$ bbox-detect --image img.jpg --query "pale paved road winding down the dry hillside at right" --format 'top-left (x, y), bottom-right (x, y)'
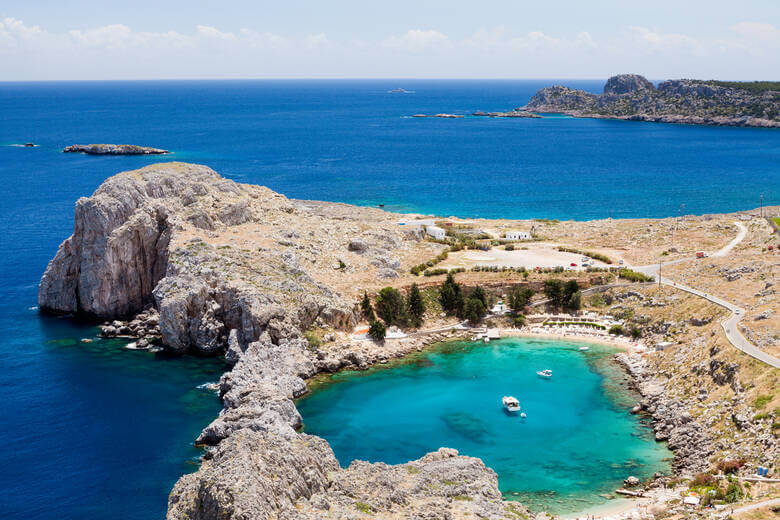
top-left (632, 222), bottom-right (780, 368)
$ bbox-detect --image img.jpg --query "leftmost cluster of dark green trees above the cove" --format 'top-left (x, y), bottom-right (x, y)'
top-left (360, 283), bottom-right (425, 341)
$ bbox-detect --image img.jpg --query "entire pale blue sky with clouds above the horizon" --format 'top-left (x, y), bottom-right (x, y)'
top-left (0, 0), bottom-right (780, 81)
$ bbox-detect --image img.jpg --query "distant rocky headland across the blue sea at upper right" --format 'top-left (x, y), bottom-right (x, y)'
top-left (524, 74), bottom-right (780, 128)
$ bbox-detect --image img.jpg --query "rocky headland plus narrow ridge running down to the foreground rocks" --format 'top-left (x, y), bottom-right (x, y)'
top-left (39, 163), bottom-right (532, 520)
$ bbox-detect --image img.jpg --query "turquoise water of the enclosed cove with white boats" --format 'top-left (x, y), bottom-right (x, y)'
top-left (298, 338), bottom-right (671, 514)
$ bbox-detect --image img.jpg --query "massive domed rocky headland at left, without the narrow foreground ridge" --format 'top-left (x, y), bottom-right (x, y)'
top-left (38, 163), bottom-right (419, 352)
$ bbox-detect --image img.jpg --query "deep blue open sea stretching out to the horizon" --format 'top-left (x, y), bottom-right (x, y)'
top-left (0, 80), bottom-right (780, 520)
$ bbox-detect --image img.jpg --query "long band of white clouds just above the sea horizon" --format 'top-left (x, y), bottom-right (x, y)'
top-left (0, 18), bottom-right (780, 80)
